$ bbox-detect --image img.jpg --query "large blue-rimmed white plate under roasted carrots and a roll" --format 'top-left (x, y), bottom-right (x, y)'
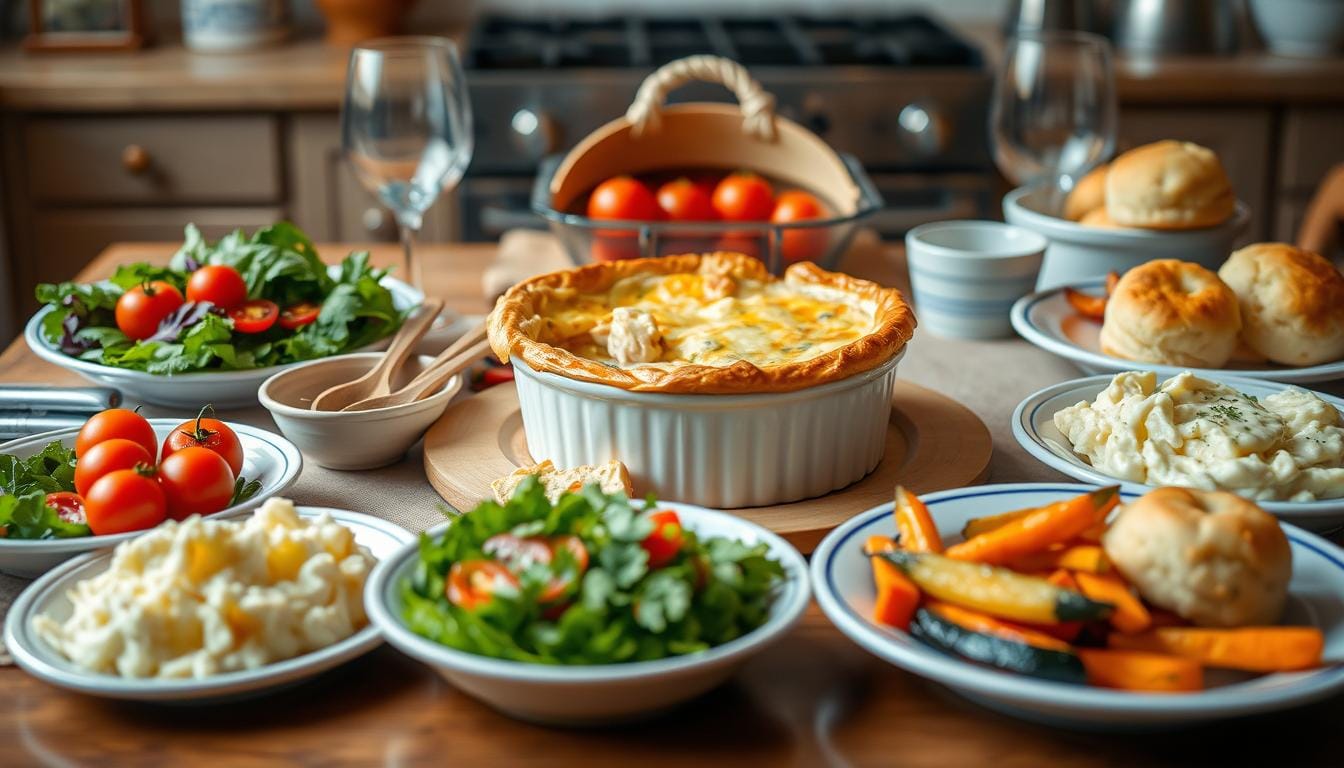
top-left (812, 483), bottom-right (1344, 729)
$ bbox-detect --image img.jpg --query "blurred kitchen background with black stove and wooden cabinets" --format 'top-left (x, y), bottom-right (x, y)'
top-left (0, 0), bottom-right (1344, 339)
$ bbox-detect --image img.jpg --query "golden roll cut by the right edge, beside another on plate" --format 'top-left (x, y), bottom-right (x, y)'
top-left (1218, 242), bottom-right (1344, 366)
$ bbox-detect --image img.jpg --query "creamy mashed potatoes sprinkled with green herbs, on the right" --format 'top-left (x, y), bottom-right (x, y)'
top-left (1054, 371), bottom-right (1344, 502)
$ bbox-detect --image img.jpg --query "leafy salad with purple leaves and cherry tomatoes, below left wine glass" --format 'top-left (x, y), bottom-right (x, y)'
top-left (36, 222), bottom-right (403, 374)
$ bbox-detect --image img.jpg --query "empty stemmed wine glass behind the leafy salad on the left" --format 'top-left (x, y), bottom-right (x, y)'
top-left (340, 36), bottom-right (472, 297)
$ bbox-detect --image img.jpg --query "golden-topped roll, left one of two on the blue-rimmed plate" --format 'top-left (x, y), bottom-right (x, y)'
top-left (1101, 258), bottom-right (1242, 369)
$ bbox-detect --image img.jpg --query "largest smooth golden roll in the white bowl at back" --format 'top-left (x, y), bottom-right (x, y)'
top-left (1106, 140), bottom-right (1236, 230)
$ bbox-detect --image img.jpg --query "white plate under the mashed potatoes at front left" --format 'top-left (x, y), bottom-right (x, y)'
top-left (4, 507), bottom-right (415, 703)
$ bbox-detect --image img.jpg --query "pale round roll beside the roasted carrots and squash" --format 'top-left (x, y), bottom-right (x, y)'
top-left (1102, 488), bottom-right (1293, 627)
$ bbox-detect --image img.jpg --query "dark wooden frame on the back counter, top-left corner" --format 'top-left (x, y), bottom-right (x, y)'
top-left (23, 0), bottom-right (148, 52)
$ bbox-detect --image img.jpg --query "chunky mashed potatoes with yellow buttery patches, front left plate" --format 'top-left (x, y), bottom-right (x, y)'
top-left (34, 499), bottom-right (374, 678)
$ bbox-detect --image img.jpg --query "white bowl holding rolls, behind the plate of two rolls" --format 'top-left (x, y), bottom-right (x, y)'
top-left (1004, 187), bottom-right (1251, 289)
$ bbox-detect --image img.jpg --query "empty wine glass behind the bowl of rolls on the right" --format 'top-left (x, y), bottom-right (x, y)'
top-left (989, 31), bottom-right (1116, 208)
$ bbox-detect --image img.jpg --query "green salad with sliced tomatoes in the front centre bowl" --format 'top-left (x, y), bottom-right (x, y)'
top-left (401, 479), bottom-right (784, 664)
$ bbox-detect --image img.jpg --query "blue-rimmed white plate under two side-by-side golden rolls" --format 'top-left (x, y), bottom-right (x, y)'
top-left (1009, 280), bottom-right (1344, 383)
